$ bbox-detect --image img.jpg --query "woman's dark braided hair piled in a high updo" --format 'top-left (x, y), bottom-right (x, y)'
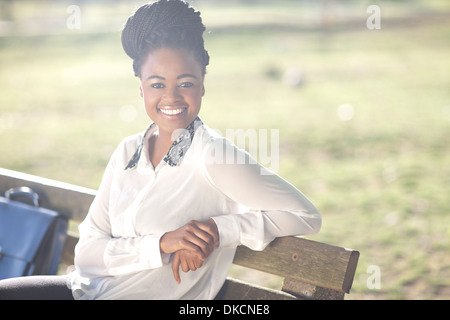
top-left (122, 0), bottom-right (209, 77)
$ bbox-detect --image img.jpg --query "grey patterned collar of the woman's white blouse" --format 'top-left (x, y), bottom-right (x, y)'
top-left (124, 116), bottom-right (203, 170)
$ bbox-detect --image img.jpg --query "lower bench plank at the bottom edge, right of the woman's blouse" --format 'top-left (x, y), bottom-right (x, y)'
top-left (216, 278), bottom-right (298, 300)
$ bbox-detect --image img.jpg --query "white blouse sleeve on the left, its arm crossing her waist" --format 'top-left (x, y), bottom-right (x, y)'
top-left (75, 142), bottom-right (167, 276)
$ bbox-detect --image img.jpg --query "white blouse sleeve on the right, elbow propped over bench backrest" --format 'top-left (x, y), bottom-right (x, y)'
top-left (205, 139), bottom-right (321, 250)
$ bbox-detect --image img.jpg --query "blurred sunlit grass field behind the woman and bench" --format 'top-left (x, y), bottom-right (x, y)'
top-left (0, 0), bottom-right (450, 299)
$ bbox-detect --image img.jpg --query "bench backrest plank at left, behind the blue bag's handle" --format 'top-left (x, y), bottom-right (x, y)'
top-left (0, 168), bottom-right (96, 222)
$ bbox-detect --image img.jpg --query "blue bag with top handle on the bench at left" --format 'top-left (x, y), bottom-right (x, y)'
top-left (0, 187), bottom-right (67, 279)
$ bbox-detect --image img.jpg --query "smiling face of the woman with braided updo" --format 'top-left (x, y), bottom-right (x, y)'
top-left (140, 47), bottom-right (204, 135)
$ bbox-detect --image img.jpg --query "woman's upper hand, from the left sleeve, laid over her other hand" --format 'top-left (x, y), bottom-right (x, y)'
top-left (159, 219), bottom-right (219, 261)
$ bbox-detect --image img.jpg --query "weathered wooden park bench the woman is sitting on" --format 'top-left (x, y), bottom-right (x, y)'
top-left (0, 168), bottom-right (359, 300)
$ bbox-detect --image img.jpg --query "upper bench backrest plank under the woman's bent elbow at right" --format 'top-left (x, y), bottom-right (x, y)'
top-left (234, 237), bottom-right (359, 293)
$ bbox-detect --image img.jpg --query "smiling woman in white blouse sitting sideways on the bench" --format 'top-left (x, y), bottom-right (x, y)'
top-left (0, 0), bottom-right (321, 299)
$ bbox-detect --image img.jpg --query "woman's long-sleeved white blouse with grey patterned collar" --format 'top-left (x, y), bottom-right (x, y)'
top-left (69, 117), bottom-right (321, 299)
